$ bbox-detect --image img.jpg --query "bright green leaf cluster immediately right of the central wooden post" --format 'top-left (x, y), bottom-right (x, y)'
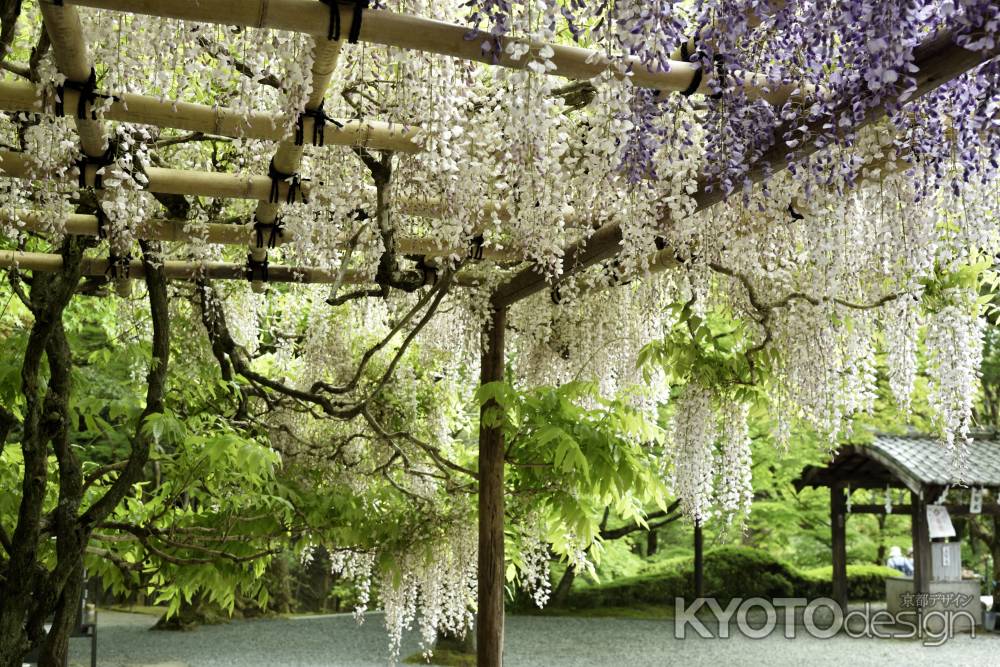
top-left (477, 382), bottom-right (666, 578)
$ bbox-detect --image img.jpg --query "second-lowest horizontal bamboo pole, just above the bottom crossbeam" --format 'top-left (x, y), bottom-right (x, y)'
top-left (0, 210), bottom-right (521, 261)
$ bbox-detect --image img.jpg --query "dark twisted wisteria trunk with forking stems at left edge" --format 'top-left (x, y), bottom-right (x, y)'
top-left (0, 236), bottom-right (170, 667)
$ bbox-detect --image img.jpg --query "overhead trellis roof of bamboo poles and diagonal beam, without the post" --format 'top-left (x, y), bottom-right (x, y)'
top-left (0, 0), bottom-right (992, 298)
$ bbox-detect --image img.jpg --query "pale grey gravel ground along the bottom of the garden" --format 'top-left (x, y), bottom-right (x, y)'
top-left (71, 612), bottom-right (1000, 667)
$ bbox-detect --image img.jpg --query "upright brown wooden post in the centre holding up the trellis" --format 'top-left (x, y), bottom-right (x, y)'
top-left (476, 307), bottom-right (507, 667)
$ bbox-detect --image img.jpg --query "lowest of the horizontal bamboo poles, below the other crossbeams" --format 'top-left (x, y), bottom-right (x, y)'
top-left (0, 250), bottom-right (482, 287)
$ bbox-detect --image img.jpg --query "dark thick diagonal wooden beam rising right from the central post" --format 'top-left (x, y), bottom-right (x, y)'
top-left (493, 33), bottom-right (1000, 306)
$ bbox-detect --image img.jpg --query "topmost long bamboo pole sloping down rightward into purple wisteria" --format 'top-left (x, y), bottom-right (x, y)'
top-left (66, 0), bottom-right (795, 103)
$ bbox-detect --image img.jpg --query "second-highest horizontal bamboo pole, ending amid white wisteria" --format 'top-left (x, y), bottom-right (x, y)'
top-left (0, 81), bottom-right (420, 153)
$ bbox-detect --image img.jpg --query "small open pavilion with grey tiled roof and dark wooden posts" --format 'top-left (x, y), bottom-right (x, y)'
top-left (795, 435), bottom-right (1000, 609)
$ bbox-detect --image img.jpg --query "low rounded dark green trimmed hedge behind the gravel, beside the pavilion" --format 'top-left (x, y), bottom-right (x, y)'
top-left (563, 546), bottom-right (898, 609)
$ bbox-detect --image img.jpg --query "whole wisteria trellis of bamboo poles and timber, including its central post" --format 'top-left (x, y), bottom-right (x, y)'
top-left (0, 0), bottom-right (995, 667)
